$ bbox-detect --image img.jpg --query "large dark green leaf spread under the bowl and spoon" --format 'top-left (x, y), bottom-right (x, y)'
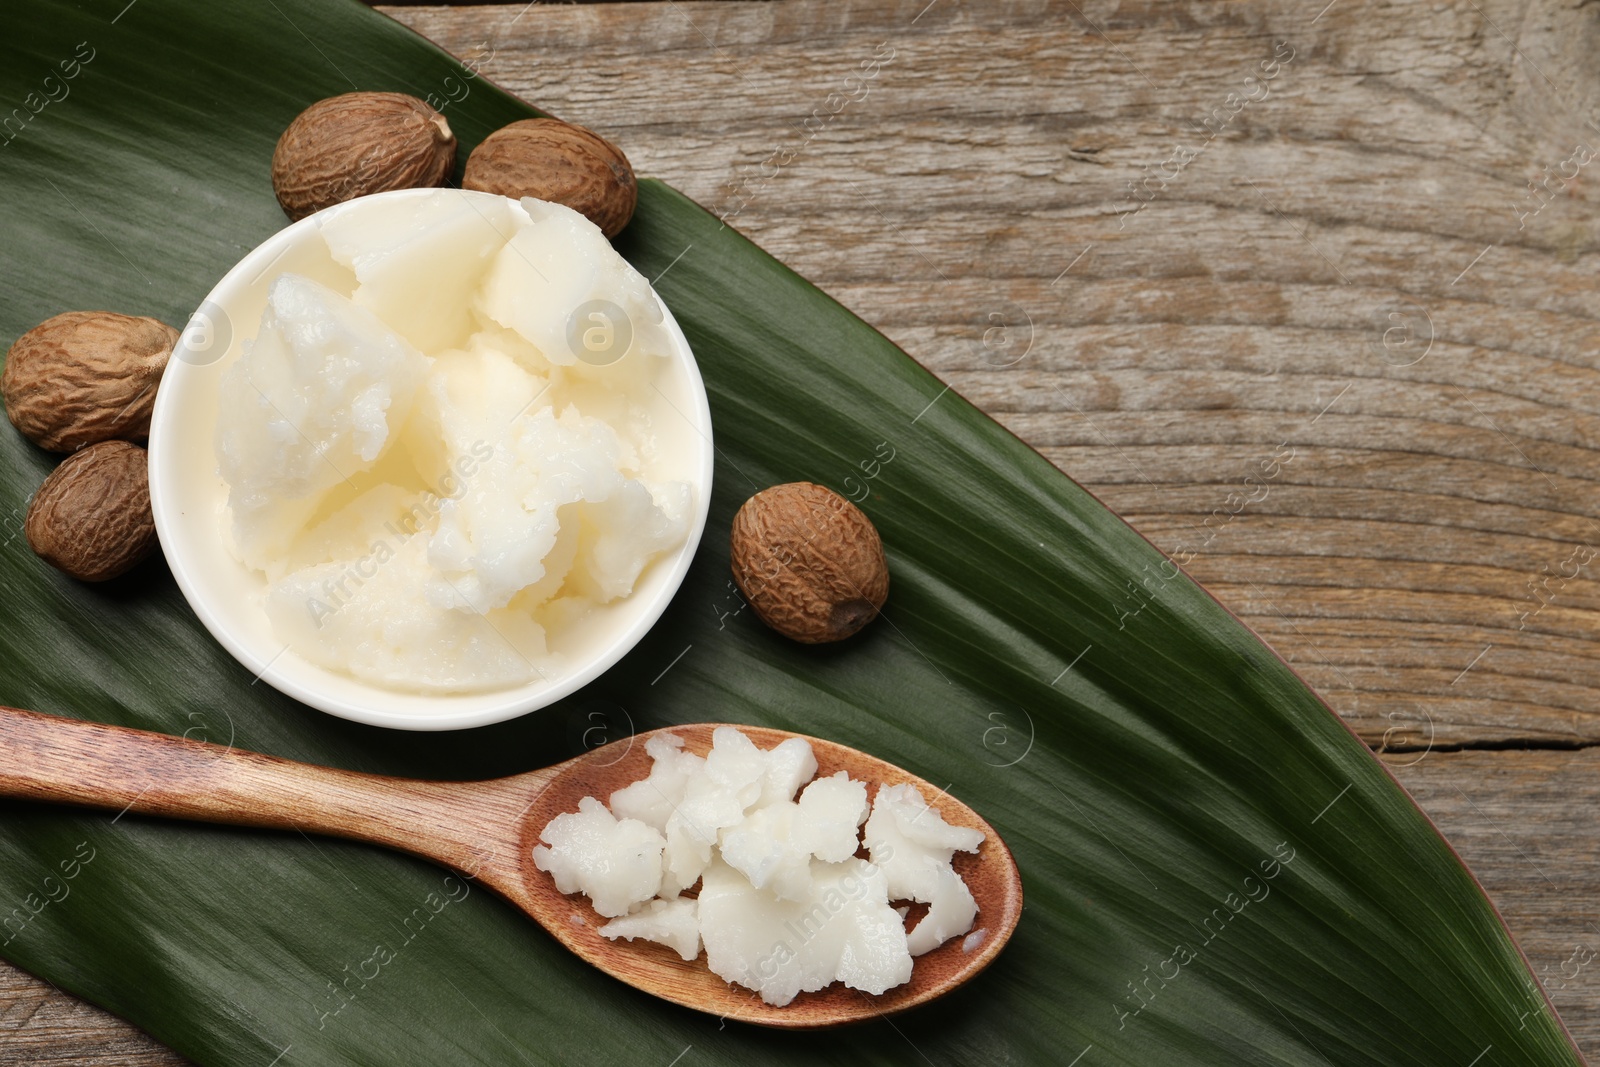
top-left (0, 0), bottom-right (1581, 1067)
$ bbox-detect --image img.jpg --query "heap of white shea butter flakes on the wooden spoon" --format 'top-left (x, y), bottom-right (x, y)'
top-left (536, 726), bottom-right (982, 1005)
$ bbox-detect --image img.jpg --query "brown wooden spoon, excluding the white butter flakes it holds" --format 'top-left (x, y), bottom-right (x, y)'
top-left (0, 709), bottom-right (1022, 1029)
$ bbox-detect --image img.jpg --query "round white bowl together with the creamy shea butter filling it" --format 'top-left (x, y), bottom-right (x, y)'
top-left (150, 189), bottom-right (712, 729)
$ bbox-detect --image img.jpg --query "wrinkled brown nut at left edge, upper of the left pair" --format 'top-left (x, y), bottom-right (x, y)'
top-left (0, 312), bottom-right (178, 453)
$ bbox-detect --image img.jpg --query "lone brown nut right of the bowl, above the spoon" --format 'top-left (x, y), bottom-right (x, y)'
top-left (733, 482), bottom-right (890, 645)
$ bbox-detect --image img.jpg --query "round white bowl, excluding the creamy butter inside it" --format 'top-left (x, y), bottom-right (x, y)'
top-left (150, 189), bottom-right (714, 729)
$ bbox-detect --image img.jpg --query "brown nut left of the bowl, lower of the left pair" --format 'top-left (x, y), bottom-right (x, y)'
top-left (22, 442), bottom-right (157, 582)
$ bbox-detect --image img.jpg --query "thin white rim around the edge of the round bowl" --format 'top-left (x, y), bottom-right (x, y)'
top-left (149, 189), bottom-right (715, 731)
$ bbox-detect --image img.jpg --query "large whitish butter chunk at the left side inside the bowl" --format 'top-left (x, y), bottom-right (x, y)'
top-left (216, 274), bottom-right (429, 576)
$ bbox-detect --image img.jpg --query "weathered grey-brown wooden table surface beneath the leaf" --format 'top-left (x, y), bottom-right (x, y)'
top-left (0, 0), bottom-right (1600, 1067)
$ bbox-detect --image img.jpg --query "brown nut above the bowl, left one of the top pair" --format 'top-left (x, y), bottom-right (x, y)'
top-left (272, 93), bottom-right (456, 219)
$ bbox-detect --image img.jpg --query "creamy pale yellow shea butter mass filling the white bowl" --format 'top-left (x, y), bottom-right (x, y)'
top-left (216, 190), bottom-right (699, 694)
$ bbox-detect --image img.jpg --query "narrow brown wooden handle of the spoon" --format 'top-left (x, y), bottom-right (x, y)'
top-left (0, 707), bottom-right (544, 873)
